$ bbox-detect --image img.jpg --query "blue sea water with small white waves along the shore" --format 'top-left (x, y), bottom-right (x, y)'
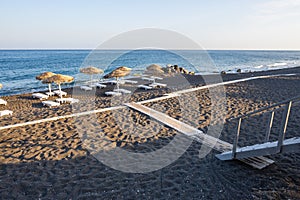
top-left (0, 50), bottom-right (300, 96)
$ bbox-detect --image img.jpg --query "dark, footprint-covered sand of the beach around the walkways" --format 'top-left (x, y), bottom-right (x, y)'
top-left (0, 68), bottom-right (300, 199)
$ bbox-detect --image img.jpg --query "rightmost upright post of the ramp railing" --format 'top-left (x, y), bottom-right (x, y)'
top-left (276, 101), bottom-right (292, 153)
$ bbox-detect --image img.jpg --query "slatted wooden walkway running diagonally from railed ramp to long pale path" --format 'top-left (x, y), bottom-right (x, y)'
top-left (125, 103), bottom-right (274, 169)
